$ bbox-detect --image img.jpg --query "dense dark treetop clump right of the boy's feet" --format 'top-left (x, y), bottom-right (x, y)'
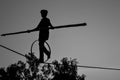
top-left (52, 58), bottom-right (85, 80)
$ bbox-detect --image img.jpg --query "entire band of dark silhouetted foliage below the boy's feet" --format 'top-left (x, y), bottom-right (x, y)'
top-left (0, 53), bottom-right (85, 80)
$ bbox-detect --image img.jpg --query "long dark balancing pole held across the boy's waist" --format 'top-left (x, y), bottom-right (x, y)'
top-left (1, 23), bottom-right (87, 36)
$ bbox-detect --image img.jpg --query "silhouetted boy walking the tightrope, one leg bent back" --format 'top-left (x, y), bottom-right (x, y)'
top-left (34, 9), bottom-right (53, 63)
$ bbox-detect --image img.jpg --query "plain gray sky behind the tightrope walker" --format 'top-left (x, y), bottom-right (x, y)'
top-left (0, 0), bottom-right (120, 80)
